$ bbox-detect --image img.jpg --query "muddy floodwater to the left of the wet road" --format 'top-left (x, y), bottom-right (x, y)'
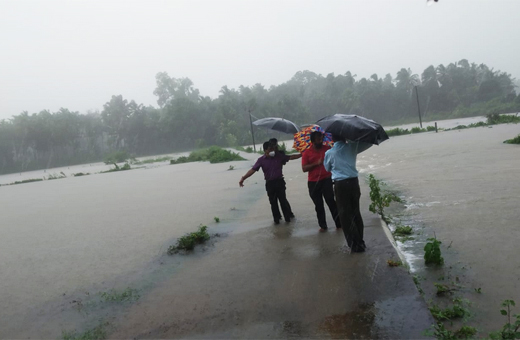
top-left (0, 154), bottom-right (264, 338)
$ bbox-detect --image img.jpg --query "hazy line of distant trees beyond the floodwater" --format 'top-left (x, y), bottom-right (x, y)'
top-left (0, 59), bottom-right (520, 174)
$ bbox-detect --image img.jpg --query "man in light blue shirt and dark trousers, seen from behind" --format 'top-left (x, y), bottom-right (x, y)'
top-left (323, 134), bottom-right (372, 253)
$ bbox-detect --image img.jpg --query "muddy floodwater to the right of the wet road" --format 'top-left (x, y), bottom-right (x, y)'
top-left (359, 120), bottom-right (520, 334)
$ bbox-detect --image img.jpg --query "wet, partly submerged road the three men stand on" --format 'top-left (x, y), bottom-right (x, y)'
top-left (110, 162), bottom-right (433, 339)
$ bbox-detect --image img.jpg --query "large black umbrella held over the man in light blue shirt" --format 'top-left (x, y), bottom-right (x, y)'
top-left (316, 113), bottom-right (388, 144)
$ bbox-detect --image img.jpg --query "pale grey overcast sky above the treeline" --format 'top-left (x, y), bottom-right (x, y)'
top-left (0, 0), bottom-right (520, 119)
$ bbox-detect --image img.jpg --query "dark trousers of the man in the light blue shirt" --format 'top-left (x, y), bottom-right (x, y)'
top-left (334, 177), bottom-right (365, 251)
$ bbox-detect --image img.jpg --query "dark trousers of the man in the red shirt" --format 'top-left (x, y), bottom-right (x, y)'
top-left (307, 177), bottom-right (341, 229)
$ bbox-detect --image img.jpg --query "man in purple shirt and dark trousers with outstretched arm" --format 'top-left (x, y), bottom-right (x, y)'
top-left (238, 142), bottom-right (302, 224)
